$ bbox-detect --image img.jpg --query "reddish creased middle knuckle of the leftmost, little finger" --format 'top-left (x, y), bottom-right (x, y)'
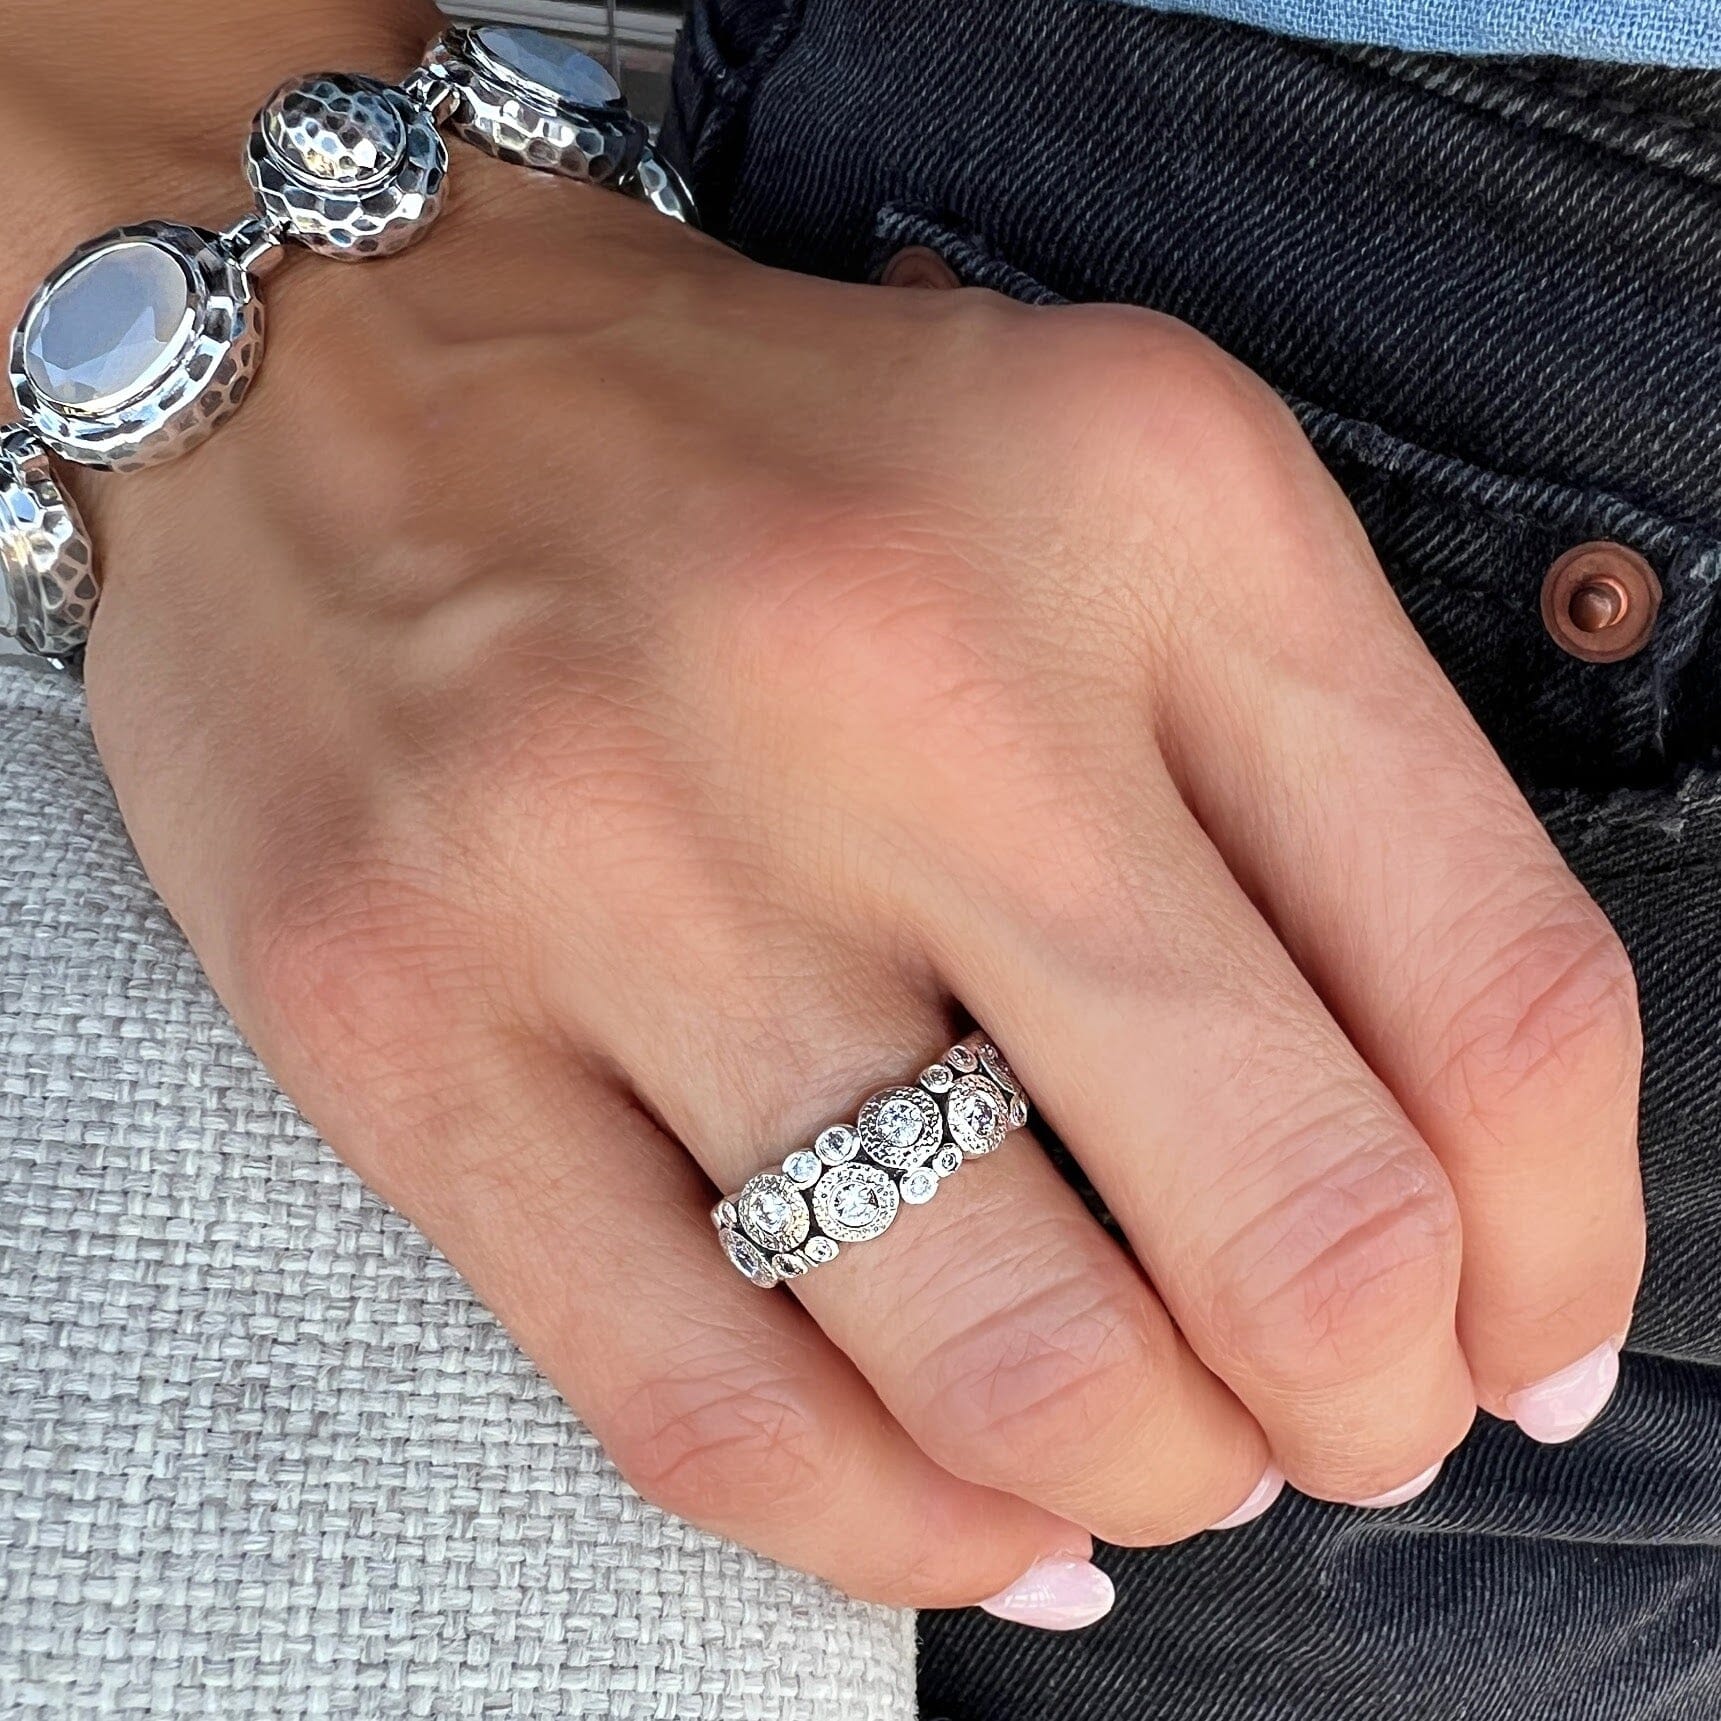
top-left (604, 1360), bottom-right (831, 1525)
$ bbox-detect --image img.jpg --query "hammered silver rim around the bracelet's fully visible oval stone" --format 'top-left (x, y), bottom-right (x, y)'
top-left (10, 220), bottom-right (263, 472)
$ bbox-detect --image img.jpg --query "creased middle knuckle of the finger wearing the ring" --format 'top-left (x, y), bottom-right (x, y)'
top-left (917, 1268), bottom-right (1163, 1485)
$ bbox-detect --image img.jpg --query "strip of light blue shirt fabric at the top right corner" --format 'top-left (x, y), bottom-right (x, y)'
top-left (1108, 0), bottom-right (1721, 67)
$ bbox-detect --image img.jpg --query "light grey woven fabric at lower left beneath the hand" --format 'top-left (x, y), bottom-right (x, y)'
top-left (0, 661), bottom-right (914, 1721)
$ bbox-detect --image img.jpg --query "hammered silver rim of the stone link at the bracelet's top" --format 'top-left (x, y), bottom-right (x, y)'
top-left (423, 24), bottom-right (647, 186)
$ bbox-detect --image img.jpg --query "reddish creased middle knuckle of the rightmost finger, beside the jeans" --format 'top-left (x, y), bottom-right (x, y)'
top-left (1427, 902), bottom-right (1644, 1124)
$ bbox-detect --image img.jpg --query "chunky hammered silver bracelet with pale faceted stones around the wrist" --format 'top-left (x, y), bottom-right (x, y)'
top-left (0, 24), bottom-right (697, 666)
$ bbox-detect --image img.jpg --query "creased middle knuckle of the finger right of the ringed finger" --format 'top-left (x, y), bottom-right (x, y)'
top-left (1200, 1115), bottom-right (1459, 1392)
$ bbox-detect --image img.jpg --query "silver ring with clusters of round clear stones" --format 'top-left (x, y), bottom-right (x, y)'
top-left (711, 1034), bottom-right (1029, 1291)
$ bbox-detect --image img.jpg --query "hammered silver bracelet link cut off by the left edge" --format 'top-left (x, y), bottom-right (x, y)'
top-left (0, 427), bottom-right (102, 663)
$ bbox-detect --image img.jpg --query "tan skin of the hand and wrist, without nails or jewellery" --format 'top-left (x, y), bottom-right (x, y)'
top-left (0, 0), bottom-right (1644, 1606)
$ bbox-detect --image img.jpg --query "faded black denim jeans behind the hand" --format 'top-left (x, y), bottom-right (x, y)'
top-left (669, 0), bottom-right (1721, 1721)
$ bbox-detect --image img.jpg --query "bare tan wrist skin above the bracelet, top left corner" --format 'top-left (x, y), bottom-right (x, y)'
top-left (0, 0), bottom-right (442, 324)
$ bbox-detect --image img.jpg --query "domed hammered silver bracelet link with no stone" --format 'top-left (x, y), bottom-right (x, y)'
top-left (244, 72), bottom-right (447, 262)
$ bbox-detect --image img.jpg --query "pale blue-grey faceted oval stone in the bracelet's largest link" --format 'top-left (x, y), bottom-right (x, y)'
top-left (24, 239), bottom-right (196, 415)
